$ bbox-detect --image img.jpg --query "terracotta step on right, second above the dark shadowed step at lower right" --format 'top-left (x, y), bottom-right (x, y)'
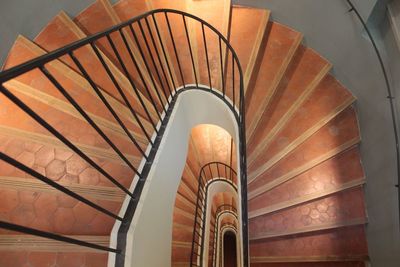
top-left (248, 147), bottom-right (365, 218)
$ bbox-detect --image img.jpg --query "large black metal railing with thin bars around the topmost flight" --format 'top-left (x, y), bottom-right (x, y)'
top-left (0, 9), bottom-right (248, 266)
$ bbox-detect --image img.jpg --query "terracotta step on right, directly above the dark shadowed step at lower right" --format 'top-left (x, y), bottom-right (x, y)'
top-left (249, 187), bottom-right (366, 240)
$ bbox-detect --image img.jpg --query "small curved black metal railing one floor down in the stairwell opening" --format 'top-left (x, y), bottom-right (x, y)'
top-left (189, 162), bottom-right (237, 266)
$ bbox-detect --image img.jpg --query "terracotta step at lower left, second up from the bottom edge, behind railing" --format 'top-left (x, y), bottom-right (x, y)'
top-left (0, 183), bottom-right (121, 236)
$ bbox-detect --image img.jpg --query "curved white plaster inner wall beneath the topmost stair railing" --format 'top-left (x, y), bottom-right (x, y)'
top-left (109, 90), bottom-right (241, 267)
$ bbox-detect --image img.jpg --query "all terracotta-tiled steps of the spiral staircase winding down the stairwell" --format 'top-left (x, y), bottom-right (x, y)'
top-left (0, 0), bottom-right (368, 267)
